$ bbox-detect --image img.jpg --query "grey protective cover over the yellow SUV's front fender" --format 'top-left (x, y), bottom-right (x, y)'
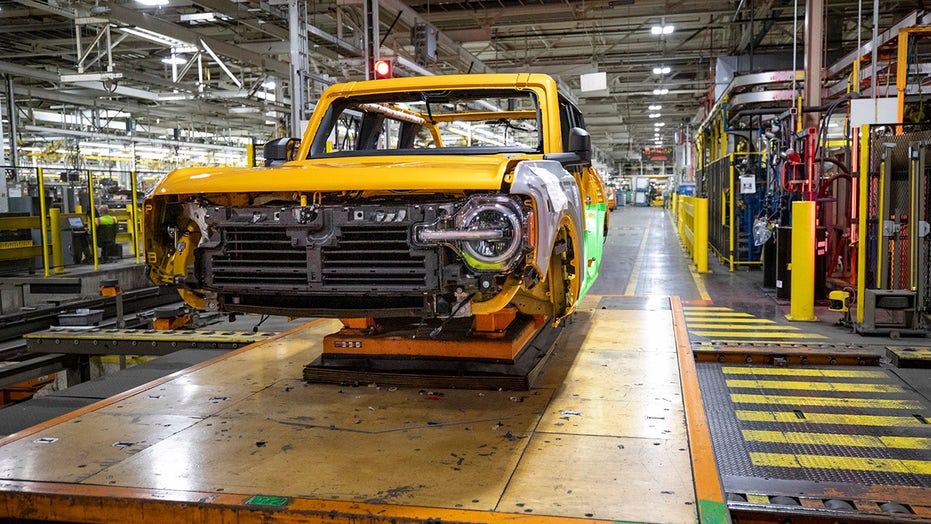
top-left (511, 160), bottom-right (585, 279)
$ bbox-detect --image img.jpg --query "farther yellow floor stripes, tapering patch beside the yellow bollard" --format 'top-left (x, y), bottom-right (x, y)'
top-left (683, 306), bottom-right (827, 344)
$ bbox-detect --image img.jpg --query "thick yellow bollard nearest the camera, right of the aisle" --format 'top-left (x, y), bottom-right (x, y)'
top-left (786, 201), bottom-right (818, 322)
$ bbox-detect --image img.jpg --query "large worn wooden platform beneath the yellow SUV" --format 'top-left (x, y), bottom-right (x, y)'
top-left (0, 297), bottom-right (699, 523)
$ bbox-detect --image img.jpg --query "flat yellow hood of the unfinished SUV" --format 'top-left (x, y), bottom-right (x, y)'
top-left (150, 155), bottom-right (524, 197)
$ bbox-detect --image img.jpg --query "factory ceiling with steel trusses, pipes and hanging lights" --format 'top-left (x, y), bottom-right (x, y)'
top-left (0, 0), bottom-right (923, 171)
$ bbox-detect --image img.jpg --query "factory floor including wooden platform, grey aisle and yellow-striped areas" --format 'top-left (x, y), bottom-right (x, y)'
top-left (0, 207), bottom-right (931, 523)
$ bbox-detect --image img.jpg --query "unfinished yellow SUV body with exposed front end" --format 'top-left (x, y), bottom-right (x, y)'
top-left (144, 74), bottom-right (607, 322)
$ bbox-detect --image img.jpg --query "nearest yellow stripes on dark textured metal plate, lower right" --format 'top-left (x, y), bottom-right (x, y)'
top-left (719, 365), bottom-right (931, 482)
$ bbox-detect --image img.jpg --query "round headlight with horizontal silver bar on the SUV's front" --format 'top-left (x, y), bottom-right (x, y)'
top-left (415, 195), bottom-right (529, 271)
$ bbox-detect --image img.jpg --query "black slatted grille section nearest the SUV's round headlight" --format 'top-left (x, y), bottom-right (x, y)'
top-left (321, 226), bottom-right (427, 291)
